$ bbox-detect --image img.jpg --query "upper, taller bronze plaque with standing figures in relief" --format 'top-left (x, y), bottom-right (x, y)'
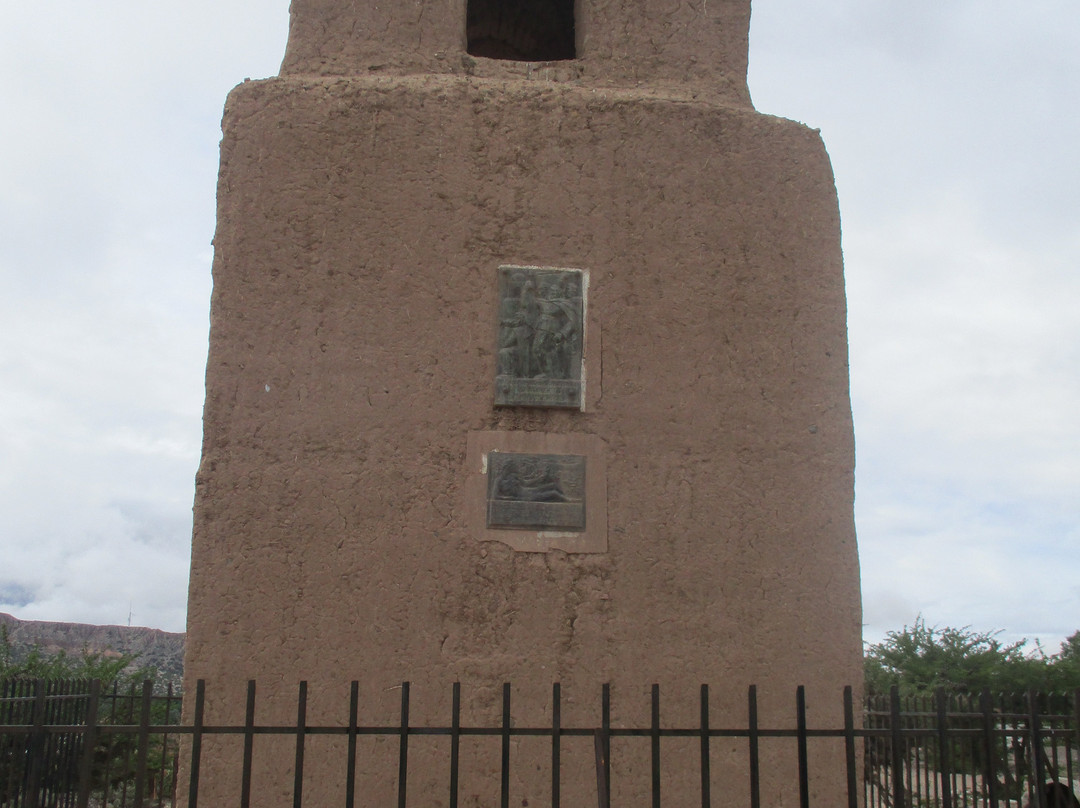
top-left (495, 267), bottom-right (584, 409)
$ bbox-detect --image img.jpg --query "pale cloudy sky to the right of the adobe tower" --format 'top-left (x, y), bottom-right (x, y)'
top-left (751, 0), bottom-right (1080, 649)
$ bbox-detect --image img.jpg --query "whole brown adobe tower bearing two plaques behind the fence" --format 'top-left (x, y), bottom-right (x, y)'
top-left (186, 0), bottom-right (861, 806)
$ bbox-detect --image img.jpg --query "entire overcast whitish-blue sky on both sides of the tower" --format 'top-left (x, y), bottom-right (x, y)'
top-left (0, 0), bottom-right (1080, 651)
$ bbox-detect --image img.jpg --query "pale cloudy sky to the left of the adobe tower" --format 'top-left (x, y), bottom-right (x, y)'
top-left (0, 0), bottom-right (287, 631)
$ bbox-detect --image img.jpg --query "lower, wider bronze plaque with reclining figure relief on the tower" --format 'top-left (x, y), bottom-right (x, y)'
top-left (487, 452), bottom-right (585, 531)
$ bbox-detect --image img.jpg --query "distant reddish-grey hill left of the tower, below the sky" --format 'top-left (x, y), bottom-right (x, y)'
top-left (0, 612), bottom-right (184, 684)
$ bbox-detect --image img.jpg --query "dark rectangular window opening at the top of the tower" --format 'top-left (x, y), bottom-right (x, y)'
top-left (465, 0), bottom-right (576, 62)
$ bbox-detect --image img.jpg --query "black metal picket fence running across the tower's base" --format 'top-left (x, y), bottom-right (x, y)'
top-left (0, 681), bottom-right (1080, 808)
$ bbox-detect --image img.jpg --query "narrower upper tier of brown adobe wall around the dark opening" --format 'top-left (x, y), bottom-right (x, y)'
top-left (281, 0), bottom-right (750, 106)
